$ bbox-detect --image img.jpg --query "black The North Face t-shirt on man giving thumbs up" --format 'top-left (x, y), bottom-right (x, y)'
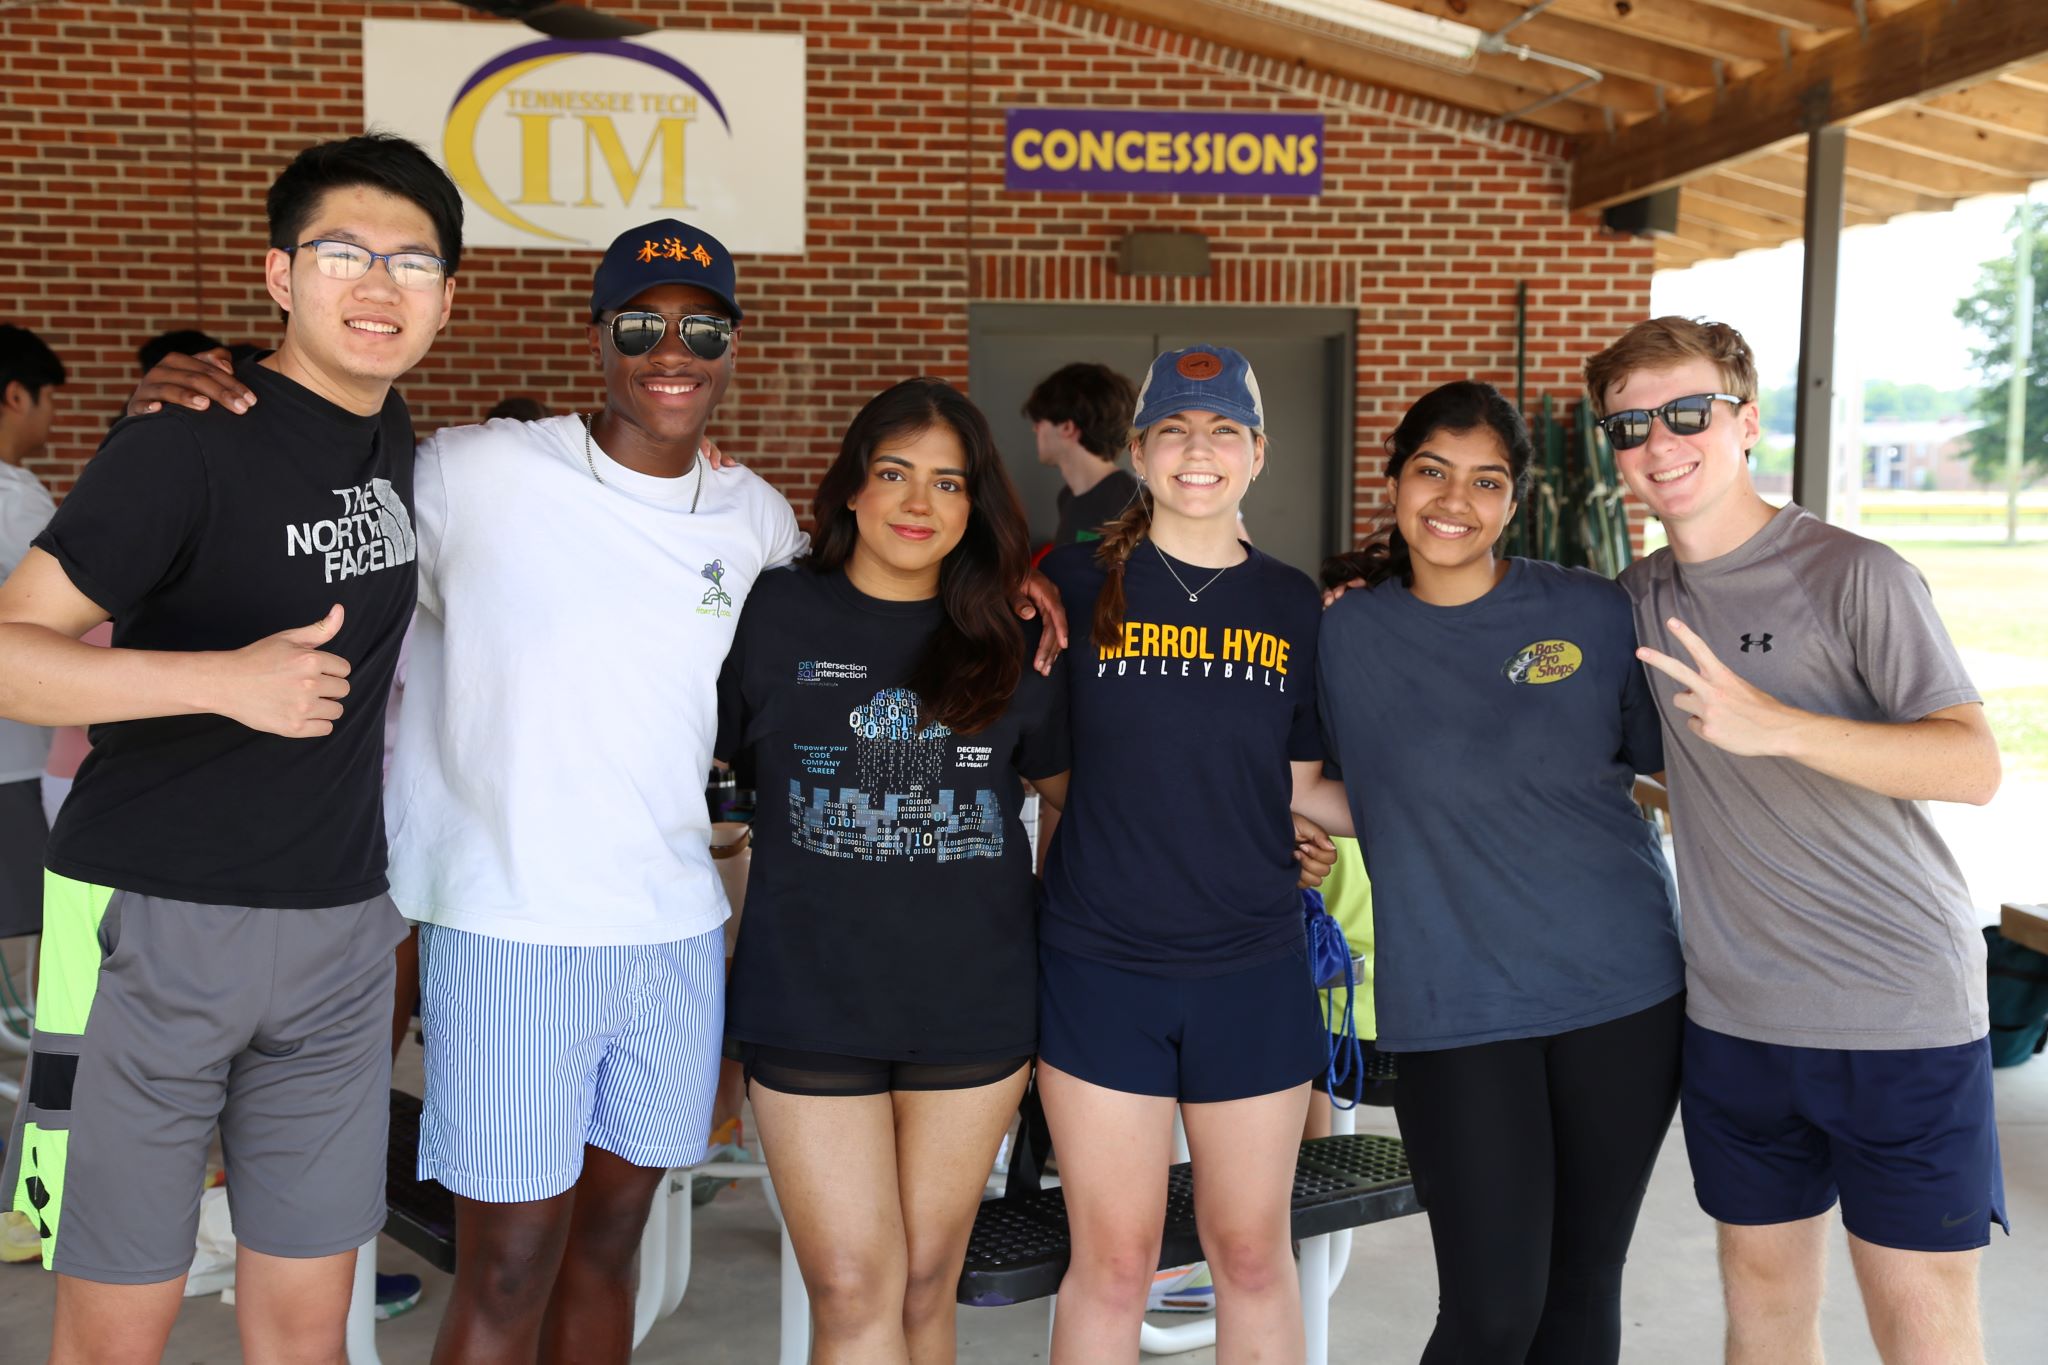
top-left (35, 360), bottom-right (418, 909)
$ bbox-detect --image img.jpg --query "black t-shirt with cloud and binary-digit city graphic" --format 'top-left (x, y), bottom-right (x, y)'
top-left (717, 567), bottom-right (1067, 1062)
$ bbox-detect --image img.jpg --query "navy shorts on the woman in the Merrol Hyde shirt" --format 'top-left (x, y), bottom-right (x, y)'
top-left (1038, 943), bottom-right (1329, 1105)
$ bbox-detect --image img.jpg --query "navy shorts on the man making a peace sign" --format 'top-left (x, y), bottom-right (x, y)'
top-left (1679, 1019), bottom-right (2011, 1250)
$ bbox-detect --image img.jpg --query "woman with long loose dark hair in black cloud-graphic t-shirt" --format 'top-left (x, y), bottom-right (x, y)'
top-left (717, 379), bottom-right (1067, 1365)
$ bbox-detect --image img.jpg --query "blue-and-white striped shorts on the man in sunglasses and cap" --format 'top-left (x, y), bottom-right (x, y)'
top-left (420, 925), bottom-right (725, 1203)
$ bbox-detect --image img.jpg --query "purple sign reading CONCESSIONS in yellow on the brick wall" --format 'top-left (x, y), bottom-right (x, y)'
top-left (1004, 106), bottom-right (1323, 196)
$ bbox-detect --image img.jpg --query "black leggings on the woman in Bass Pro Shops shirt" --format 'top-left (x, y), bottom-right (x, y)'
top-left (1395, 993), bottom-right (1686, 1365)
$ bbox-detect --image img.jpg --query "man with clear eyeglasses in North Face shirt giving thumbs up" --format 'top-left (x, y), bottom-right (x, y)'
top-left (0, 135), bottom-right (463, 1365)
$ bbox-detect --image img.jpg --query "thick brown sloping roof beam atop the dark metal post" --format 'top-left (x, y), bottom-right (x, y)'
top-left (1571, 0), bottom-right (2048, 209)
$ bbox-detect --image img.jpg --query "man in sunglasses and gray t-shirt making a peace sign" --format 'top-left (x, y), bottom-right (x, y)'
top-left (1585, 317), bottom-right (2005, 1365)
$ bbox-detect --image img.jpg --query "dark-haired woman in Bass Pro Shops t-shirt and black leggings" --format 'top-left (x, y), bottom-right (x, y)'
top-left (1317, 381), bottom-right (1686, 1365)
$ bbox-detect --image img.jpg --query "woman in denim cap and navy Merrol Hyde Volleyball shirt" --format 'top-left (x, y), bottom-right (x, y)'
top-left (1038, 346), bottom-right (1348, 1361)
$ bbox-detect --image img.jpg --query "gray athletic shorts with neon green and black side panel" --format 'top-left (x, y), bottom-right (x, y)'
top-left (0, 874), bottom-right (406, 1285)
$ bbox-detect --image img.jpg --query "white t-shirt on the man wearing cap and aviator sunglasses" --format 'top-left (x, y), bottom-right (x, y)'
top-left (385, 417), bottom-right (809, 945)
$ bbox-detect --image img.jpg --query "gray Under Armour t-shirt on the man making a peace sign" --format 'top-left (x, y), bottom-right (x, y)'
top-left (1622, 505), bottom-right (1989, 1048)
